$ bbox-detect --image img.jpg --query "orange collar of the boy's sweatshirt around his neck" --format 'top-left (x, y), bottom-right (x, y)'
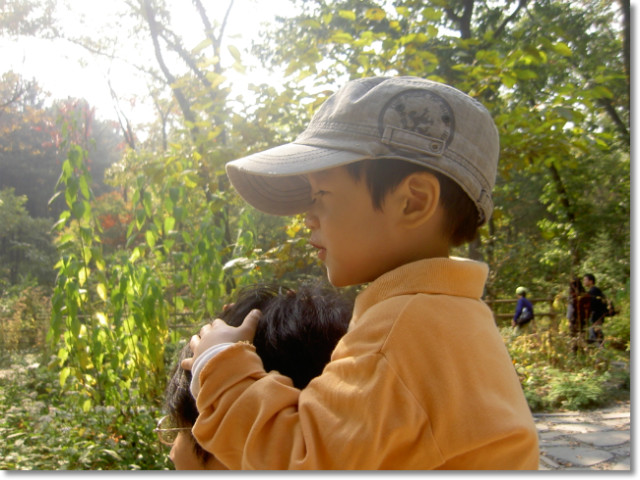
top-left (353, 257), bottom-right (489, 319)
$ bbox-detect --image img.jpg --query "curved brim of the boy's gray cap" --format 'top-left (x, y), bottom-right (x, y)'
top-left (226, 143), bottom-right (368, 215)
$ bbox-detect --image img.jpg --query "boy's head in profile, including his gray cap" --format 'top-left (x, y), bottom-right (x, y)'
top-left (227, 77), bottom-right (499, 286)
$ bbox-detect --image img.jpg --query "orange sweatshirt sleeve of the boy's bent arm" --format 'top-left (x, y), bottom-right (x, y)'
top-left (193, 344), bottom-right (443, 470)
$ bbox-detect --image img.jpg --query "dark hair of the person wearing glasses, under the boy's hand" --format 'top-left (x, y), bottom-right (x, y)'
top-left (165, 284), bottom-right (353, 463)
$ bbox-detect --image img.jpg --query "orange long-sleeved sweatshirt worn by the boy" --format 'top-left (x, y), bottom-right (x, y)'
top-left (193, 258), bottom-right (539, 470)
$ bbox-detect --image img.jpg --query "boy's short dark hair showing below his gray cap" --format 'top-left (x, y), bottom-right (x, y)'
top-left (346, 158), bottom-right (479, 247)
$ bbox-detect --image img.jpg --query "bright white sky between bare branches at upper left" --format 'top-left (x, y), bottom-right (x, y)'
top-left (0, 0), bottom-right (291, 124)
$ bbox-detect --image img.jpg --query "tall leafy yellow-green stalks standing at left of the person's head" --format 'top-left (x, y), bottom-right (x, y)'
top-left (47, 146), bottom-right (168, 411)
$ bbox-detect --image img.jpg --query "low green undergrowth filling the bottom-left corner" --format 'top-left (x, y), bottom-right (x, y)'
top-left (0, 355), bottom-right (171, 470)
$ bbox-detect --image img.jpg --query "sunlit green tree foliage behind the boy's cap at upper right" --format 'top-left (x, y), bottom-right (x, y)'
top-left (254, 0), bottom-right (630, 298)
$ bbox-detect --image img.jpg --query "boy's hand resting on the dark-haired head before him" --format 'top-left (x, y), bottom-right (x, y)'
top-left (180, 310), bottom-right (262, 370)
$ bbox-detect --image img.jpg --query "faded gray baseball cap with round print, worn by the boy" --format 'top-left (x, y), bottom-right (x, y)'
top-left (226, 77), bottom-right (500, 224)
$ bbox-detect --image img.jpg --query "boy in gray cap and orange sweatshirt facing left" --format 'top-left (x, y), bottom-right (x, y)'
top-left (183, 77), bottom-right (538, 469)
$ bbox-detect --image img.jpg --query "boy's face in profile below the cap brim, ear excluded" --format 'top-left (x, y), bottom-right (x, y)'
top-left (305, 167), bottom-right (405, 287)
